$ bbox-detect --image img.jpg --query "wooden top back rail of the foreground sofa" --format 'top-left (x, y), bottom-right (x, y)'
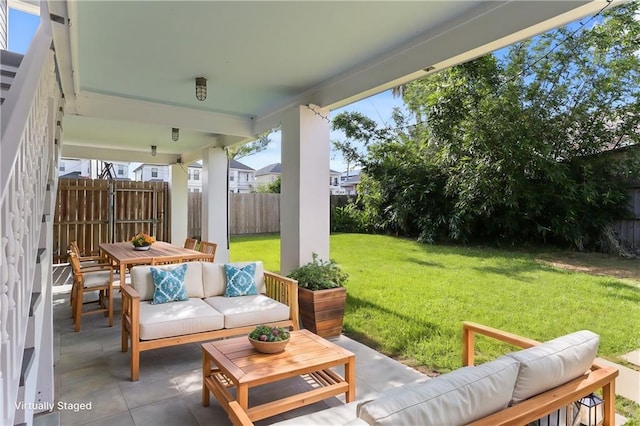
top-left (469, 367), bottom-right (618, 426)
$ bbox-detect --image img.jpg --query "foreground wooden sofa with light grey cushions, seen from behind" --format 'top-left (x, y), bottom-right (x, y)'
top-left (229, 322), bottom-right (618, 426)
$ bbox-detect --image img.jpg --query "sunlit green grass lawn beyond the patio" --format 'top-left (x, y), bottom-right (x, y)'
top-left (231, 234), bottom-right (640, 373)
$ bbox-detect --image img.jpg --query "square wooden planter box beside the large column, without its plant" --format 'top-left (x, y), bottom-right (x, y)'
top-left (298, 287), bottom-right (347, 337)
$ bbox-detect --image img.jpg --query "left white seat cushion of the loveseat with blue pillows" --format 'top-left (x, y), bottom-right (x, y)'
top-left (140, 298), bottom-right (224, 340)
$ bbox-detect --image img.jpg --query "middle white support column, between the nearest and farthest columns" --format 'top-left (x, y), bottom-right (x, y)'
top-left (200, 148), bottom-right (229, 263)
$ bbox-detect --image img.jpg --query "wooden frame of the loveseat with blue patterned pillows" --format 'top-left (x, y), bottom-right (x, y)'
top-left (120, 271), bottom-right (299, 381)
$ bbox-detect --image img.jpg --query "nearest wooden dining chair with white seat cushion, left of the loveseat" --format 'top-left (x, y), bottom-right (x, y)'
top-left (69, 250), bottom-right (113, 331)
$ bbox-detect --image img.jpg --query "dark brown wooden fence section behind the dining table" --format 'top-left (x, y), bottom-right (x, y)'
top-left (53, 178), bottom-right (171, 262)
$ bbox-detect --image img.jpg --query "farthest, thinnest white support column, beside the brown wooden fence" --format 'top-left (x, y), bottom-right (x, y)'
top-left (169, 164), bottom-right (189, 246)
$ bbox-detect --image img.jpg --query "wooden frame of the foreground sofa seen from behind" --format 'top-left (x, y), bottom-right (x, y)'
top-left (228, 322), bottom-right (618, 426)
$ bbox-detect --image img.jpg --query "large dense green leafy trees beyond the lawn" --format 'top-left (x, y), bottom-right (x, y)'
top-left (363, 2), bottom-right (640, 249)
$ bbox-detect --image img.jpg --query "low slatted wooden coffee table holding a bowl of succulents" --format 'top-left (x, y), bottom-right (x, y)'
top-left (202, 330), bottom-right (356, 422)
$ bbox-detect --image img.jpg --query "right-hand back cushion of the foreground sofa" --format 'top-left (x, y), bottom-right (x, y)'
top-left (505, 330), bottom-right (600, 404)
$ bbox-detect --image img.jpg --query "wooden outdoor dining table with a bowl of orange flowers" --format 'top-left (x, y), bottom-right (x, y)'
top-left (98, 241), bottom-right (213, 280)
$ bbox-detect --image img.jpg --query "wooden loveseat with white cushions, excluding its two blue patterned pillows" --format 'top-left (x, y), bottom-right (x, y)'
top-left (121, 262), bottom-right (299, 381)
